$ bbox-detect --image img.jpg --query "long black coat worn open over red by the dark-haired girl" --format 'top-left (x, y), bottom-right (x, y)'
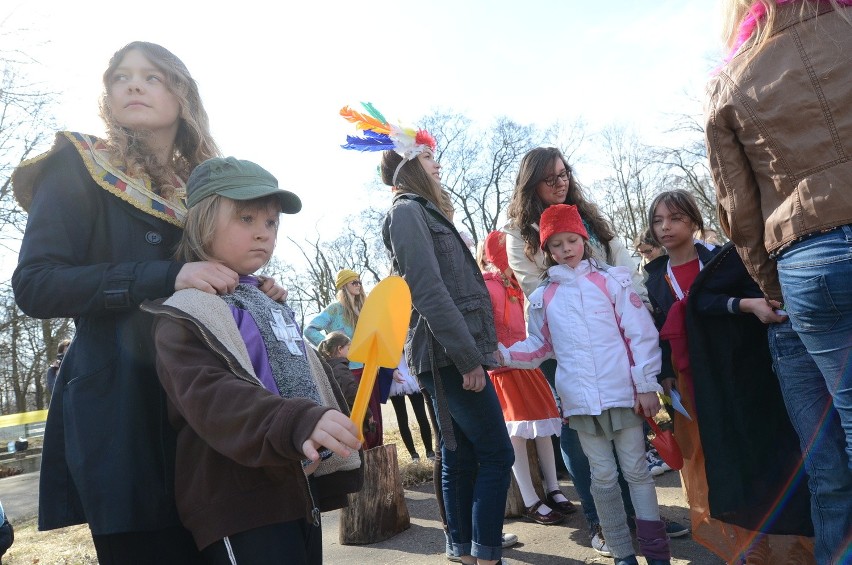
top-left (646, 243), bottom-right (813, 536)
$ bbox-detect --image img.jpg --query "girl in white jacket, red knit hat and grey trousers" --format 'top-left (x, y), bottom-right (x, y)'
top-left (500, 204), bottom-right (670, 565)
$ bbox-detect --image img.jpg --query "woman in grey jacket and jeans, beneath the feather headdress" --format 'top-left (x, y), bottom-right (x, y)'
top-left (381, 137), bottom-right (514, 564)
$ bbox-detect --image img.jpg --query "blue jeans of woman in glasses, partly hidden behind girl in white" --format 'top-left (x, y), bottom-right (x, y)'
top-left (539, 359), bottom-right (636, 530)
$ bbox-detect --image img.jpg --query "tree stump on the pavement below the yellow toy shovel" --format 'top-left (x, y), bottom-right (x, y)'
top-left (338, 444), bottom-right (411, 545)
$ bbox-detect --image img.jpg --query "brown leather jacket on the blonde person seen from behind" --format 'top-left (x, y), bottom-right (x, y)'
top-left (705, 3), bottom-right (852, 300)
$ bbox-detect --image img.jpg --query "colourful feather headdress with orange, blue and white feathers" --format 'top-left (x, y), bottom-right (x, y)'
top-left (340, 102), bottom-right (436, 184)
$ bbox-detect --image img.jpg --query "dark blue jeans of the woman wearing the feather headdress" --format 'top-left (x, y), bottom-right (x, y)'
top-left (418, 367), bottom-right (515, 560)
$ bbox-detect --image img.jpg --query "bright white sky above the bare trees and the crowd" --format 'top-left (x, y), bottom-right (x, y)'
top-left (5, 0), bottom-right (721, 260)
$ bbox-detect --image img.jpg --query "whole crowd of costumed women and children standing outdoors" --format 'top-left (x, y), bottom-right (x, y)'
top-left (12, 0), bottom-right (852, 565)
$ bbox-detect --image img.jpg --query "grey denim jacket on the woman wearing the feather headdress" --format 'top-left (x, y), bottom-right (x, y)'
top-left (382, 194), bottom-right (497, 375)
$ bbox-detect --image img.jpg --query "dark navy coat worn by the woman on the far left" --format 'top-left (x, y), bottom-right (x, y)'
top-left (12, 138), bottom-right (183, 535)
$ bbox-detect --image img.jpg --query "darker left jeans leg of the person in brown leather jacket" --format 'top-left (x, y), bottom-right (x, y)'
top-left (768, 320), bottom-right (852, 564)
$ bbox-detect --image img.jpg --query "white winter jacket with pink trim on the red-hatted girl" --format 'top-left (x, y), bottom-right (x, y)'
top-left (499, 260), bottom-right (662, 416)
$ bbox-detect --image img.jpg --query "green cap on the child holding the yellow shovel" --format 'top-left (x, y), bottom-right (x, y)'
top-left (186, 157), bottom-right (302, 214)
